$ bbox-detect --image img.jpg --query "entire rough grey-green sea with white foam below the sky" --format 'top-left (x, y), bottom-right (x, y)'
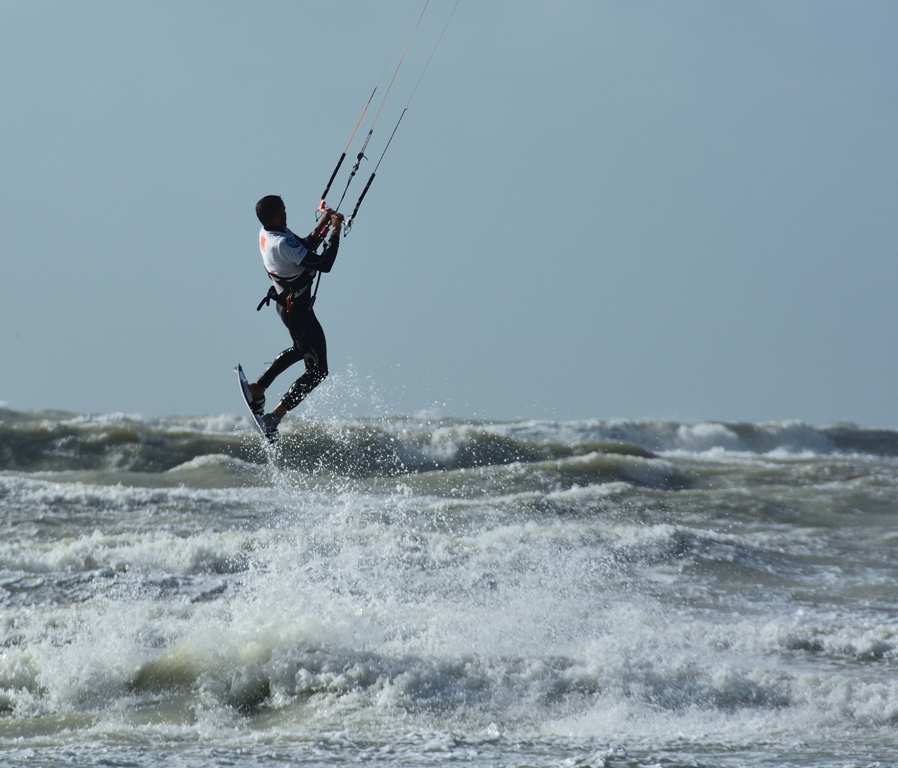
top-left (0, 408), bottom-right (898, 768)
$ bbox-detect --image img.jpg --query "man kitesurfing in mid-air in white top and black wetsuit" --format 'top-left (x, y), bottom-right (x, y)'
top-left (249, 195), bottom-right (343, 443)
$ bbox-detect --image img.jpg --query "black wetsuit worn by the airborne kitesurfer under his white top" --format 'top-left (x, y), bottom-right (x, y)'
top-left (258, 234), bottom-right (340, 411)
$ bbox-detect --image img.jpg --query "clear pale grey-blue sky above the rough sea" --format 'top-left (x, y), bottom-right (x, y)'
top-left (0, 0), bottom-right (898, 427)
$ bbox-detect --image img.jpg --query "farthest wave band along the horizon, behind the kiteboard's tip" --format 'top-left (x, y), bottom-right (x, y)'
top-left (0, 409), bottom-right (898, 476)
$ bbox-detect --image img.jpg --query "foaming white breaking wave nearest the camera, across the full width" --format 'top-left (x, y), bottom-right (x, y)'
top-left (10, 608), bottom-right (898, 733)
